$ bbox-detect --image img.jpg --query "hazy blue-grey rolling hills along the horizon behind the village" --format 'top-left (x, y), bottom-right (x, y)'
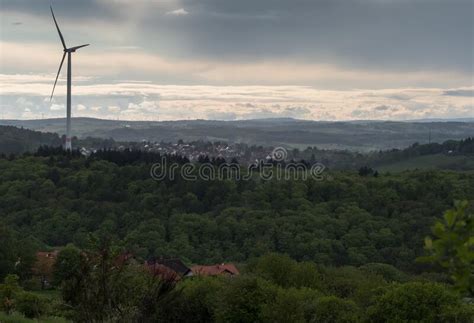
top-left (0, 118), bottom-right (474, 151)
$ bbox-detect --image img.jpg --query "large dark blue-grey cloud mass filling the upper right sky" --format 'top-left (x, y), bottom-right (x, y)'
top-left (156, 0), bottom-right (473, 71)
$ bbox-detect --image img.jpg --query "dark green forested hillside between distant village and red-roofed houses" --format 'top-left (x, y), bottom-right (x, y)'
top-left (0, 155), bottom-right (474, 271)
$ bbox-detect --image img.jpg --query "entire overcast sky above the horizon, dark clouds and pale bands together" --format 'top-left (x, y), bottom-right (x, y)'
top-left (0, 0), bottom-right (474, 120)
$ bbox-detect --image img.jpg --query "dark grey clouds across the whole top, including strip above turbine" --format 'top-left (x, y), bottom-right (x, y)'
top-left (2, 0), bottom-right (473, 73)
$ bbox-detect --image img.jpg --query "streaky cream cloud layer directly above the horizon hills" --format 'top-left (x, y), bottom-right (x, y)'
top-left (0, 74), bottom-right (474, 120)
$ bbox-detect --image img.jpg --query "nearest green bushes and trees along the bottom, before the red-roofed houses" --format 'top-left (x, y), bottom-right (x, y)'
top-left (0, 246), bottom-right (474, 323)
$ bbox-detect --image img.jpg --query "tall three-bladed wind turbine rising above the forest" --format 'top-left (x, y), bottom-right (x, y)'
top-left (49, 6), bottom-right (89, 151)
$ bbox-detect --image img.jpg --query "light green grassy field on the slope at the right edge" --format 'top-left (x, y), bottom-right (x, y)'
top-left (377, 154), bottom-right (474, 172)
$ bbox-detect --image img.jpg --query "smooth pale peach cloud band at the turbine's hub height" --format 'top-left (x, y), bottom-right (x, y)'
top-left (0, 42), bottom-right (472, 89)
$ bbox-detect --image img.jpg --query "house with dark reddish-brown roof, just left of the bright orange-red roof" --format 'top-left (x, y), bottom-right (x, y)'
top-left (145, 257), bottom-right (193, 280)
